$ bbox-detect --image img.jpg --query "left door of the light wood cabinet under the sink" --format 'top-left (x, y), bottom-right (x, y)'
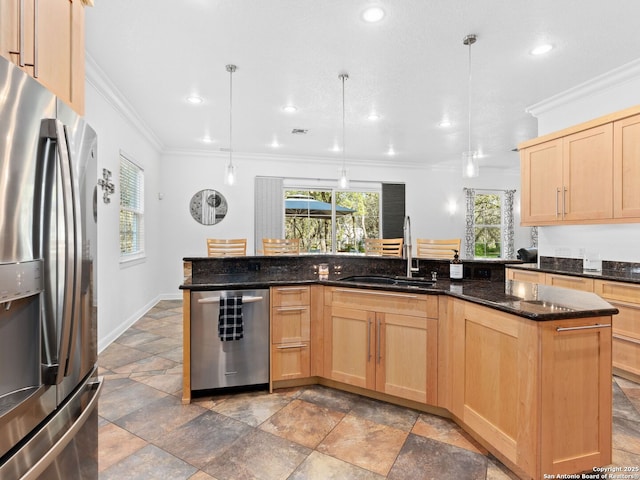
top-left (324, 307), bottom-right (376, 390)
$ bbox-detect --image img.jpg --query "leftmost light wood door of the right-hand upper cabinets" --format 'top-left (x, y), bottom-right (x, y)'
top-left (521, 139), bottom-right (562, 225)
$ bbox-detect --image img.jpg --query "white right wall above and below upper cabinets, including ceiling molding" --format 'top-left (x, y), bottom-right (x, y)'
top-left (529, 61), bottom-right (640, 262)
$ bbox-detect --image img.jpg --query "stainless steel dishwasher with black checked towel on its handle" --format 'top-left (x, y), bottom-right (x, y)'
top-left (191, 289), bottom-right (269, 390)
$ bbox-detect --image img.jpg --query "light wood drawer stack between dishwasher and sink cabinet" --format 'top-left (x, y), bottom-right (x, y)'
top-left (271, 286), bottom-right (311, 381)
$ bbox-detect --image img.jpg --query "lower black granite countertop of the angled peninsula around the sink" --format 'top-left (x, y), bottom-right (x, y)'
top-left (180, 272), bottom-right (618, 321)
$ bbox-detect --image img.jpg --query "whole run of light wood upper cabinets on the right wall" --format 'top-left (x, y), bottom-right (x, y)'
top-left (519, 107), bottom-right (640, 226)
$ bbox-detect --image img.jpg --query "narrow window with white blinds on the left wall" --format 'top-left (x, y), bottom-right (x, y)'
top-left (120, 154), bottom-right (144, 261)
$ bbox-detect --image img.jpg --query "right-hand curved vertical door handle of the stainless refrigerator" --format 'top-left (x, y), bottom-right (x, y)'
top-left (41, 119), bottom-right (79, 384)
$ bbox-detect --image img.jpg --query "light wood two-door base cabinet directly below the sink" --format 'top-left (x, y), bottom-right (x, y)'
top-left (324, 288), bottom-right (438, 404)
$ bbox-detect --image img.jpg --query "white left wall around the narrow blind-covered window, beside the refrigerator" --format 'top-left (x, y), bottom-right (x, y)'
top-left (85, 77), bottom-right (170, 351)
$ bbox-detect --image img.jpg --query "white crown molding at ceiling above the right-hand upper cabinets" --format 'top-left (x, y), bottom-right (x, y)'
top-left (525, 59), bottom-right (640, 117)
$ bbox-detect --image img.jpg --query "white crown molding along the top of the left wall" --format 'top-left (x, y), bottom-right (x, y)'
top-left (85, 52), bottom-right (164, 152)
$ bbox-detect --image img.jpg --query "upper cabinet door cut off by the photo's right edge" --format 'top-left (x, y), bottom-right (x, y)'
top-left (613, 115), bottom-right (640, 218)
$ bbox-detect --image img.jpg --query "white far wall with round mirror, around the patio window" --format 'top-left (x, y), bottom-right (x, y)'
top-left (154, 152), bottom-right (530, 296)
